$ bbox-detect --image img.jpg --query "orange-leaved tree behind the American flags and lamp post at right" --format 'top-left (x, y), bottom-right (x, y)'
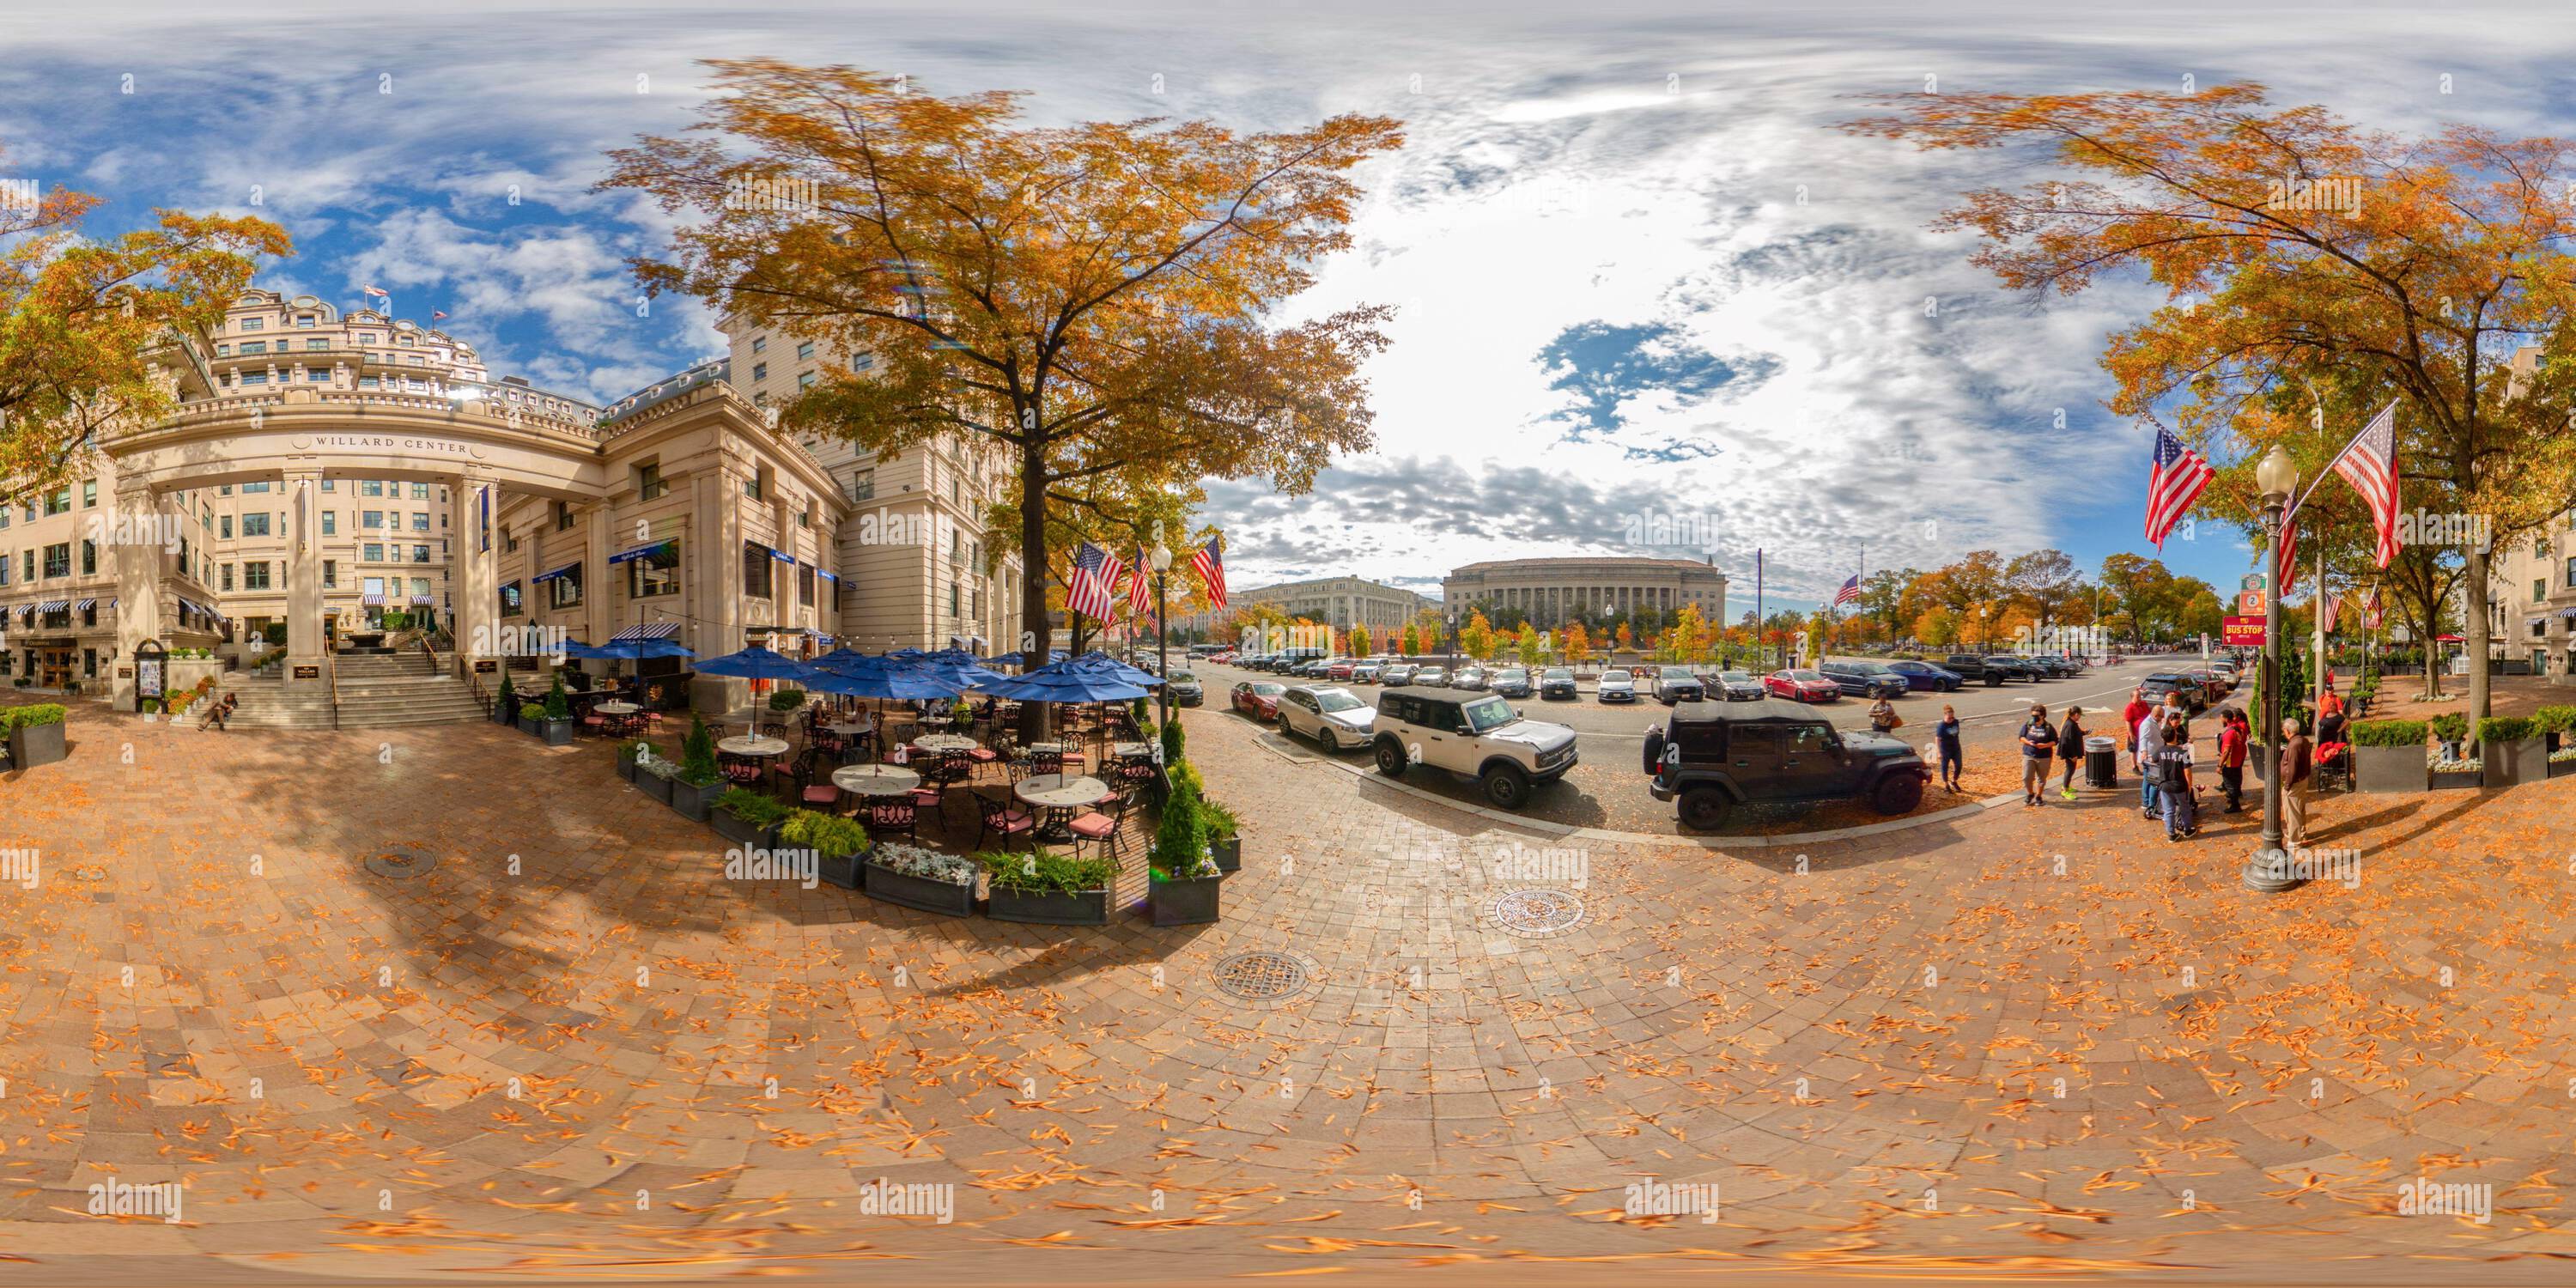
top-left (1844, 85), bottom-right (2576, 737)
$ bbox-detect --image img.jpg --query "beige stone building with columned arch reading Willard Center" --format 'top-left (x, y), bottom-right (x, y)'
top-left (0, 291), bottom-right (1018, 708)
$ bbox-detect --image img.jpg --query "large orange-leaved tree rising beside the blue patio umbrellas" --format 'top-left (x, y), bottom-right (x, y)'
top-left (603, 59), bottom-right (1401, 726)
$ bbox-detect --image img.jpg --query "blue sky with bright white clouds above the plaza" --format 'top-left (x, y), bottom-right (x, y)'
top-left (0, 0), bottom-right (2576, 605)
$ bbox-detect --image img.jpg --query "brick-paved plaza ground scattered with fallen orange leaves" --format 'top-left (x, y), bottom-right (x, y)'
top-left (0, 703), bottom-right (2576, 1283)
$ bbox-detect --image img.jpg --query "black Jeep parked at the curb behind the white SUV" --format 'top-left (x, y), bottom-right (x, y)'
top-left (1646, 698), bottom-right (1932, 832)
